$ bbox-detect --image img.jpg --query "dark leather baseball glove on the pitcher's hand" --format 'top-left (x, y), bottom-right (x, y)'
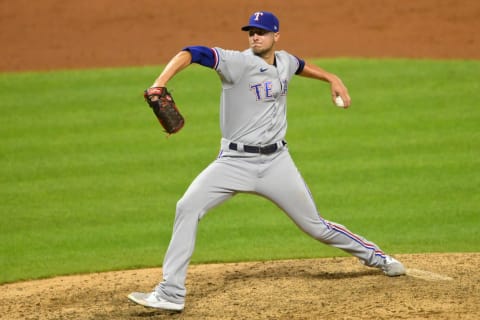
top-left (143, 87), bottom-right (185, 135)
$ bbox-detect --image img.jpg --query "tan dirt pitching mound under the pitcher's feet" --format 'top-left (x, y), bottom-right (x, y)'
top-left (0, 253), bottom-right (480, 320)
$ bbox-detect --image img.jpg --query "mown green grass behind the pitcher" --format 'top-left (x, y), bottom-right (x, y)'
top-left (0, 59), bottom-right (480, 283)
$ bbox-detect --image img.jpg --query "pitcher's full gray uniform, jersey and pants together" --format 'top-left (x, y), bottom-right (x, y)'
top-left (155, 48), bottom-right (385, 303)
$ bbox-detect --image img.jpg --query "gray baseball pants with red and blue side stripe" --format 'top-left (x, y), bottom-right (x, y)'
top-left (155, 147), bottom-right (385, 303)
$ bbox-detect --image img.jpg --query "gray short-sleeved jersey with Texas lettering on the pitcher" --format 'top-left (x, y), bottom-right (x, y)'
top-left (214, 48), bottom-right (299, 145)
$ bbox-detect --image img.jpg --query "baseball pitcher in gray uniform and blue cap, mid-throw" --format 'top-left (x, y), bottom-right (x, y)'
top-left (128, 11), bottom-right (405, 311)
